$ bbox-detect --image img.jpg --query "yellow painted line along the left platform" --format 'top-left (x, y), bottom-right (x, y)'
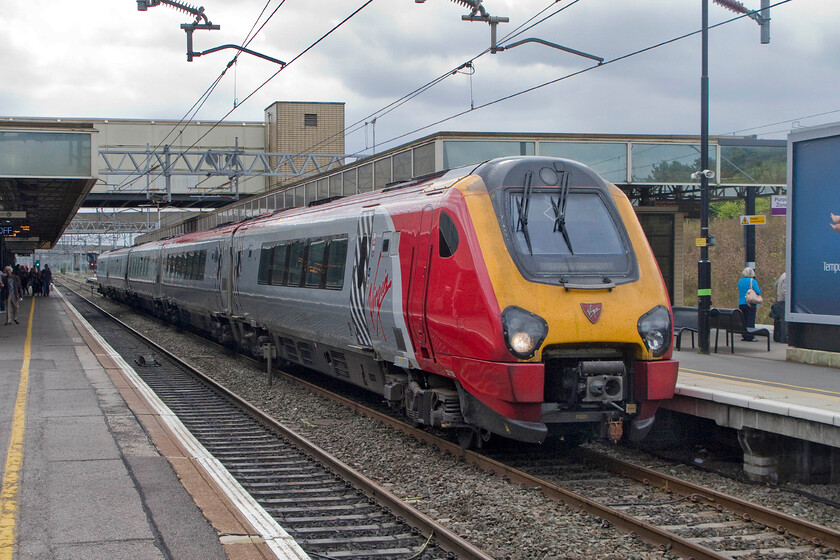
top-left (0, 297), bottom-right (35, 560)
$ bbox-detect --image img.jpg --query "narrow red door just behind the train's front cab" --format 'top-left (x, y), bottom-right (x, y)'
top-left (408, 204), bottom-right (434, 360)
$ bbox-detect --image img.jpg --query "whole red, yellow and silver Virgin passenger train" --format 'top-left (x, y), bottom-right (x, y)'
top-left (99, 156), bottom-right (677, 447)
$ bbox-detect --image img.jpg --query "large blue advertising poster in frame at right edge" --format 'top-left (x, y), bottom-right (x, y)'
top-left (787, 125), bottom-right (840, 325)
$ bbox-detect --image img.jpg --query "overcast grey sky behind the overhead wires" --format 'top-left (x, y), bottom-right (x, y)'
top-left (0, 0), bottom-right (840, 153)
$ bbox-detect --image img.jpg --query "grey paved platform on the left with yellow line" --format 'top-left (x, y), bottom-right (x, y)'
top-left (0, 290), bottom-right (305, 560)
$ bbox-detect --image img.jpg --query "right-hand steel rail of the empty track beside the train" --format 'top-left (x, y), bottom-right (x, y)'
top-left (62, 280), bottom-right (495, 560)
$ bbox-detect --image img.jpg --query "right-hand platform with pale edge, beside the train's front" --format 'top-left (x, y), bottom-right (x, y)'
top-left (662, 327), bottom-right (840, 482)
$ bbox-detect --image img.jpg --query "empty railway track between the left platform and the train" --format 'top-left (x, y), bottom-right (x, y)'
top-left (57, 284), bottom-right (492, 560)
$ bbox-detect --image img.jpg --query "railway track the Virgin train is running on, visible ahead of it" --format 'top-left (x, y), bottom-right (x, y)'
top-left (62, 278), bottom-right (840, 560)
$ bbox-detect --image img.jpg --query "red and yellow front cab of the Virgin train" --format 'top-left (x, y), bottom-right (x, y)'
top-left (420, 158), bottom-right (677, 442)
